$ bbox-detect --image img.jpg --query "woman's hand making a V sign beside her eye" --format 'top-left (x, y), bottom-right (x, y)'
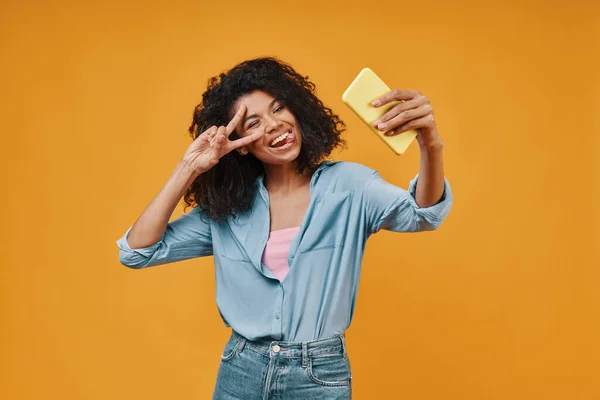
top-left (178, 105), bottom-right (263, 175)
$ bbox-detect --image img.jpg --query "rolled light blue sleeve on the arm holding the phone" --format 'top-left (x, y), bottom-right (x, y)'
top-left (365, 170), bottom-right (453, 233)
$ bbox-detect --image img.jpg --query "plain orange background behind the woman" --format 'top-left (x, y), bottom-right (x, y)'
top-left (0, 0), bottom-right (600, 400)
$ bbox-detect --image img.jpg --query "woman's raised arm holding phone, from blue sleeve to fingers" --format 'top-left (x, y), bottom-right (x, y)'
top-left (365, 90), bottom-right (453, 233)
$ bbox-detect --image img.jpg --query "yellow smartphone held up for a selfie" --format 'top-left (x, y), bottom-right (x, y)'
top-left (342, 68), bottom-right (417, 155)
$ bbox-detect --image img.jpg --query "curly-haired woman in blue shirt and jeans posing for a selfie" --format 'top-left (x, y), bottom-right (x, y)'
top-left (118, 58), bottom-right (452, 400)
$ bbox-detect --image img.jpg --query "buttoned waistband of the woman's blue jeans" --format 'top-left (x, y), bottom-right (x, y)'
top-left (232, 331), bottom-right (347, 365)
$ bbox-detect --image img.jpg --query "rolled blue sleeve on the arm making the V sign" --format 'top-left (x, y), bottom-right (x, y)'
top-left (117, 208), bottom-right (212, 269)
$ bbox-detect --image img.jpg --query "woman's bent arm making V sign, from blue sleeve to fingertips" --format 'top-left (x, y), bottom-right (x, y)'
top-left (117, 106), bottom-right (261, 268)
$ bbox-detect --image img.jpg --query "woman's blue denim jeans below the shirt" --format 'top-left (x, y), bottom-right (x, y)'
top-left (213, 332), bottom-right (352, 400)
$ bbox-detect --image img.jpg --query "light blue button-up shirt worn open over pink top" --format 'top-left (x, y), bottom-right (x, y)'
top-left (117, 162), bottom-right (452, 341)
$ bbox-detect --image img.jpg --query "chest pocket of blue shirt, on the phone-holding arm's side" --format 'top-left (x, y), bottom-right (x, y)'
top-left (300, 191), bottom-right (354, 253)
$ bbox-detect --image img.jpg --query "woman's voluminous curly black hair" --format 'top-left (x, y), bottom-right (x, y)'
top-left (184, 57), bottom-right (346, 221)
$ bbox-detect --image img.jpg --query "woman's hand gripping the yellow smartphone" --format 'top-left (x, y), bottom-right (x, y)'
top-left (373, 89), bottom-right (442, 149)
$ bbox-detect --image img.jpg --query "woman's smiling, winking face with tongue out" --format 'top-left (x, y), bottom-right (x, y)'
top-left (234, 90), bottom-right (302, 165)
